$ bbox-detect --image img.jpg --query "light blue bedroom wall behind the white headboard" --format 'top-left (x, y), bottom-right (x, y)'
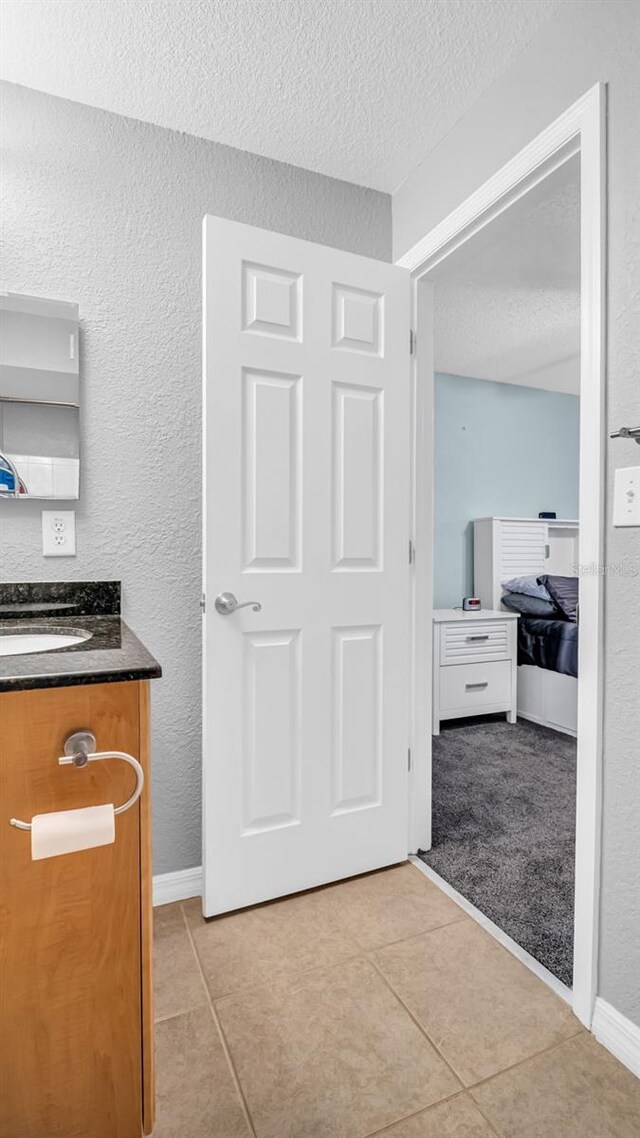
top-left (434, 374), bottom-right (580, 609)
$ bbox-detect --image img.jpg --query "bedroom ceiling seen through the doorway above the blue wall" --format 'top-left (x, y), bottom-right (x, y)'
top-left (432, 158), bottom-right (580, 395)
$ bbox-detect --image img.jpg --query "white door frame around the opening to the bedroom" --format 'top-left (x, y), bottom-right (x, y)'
top-left (396, 83), bottom-right (606, 1028)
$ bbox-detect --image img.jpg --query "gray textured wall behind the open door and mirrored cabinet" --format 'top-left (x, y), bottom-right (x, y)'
top-left (0, 84), bottom-right (391, 873)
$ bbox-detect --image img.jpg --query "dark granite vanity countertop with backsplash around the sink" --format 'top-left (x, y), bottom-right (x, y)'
top-left (0, 582), bottom-right (162, 692)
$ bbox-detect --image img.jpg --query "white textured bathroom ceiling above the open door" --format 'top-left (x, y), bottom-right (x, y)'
top-left (0, 0), bottom-right (568, 192)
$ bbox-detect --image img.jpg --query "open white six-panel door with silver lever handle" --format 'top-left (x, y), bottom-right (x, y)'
top-left (203, 217), bottom-right (410, 916)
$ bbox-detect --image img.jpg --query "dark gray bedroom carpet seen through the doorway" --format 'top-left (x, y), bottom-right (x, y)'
top-left (420, 717), bottom-right (576, 986)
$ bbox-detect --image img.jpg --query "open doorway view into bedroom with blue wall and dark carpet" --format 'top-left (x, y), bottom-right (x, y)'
top-left (419, 154), bottom-right (581, 989)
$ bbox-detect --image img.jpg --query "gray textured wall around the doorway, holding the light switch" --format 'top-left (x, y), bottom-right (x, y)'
top-left (393, 0), bottom-right (640, 1024)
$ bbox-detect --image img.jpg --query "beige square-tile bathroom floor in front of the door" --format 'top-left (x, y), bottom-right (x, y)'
top-left (154, 865), bottom-right (640, 1138)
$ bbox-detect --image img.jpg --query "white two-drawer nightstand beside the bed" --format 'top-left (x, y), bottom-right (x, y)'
top-left (433, 609), bottom-right (519, 735)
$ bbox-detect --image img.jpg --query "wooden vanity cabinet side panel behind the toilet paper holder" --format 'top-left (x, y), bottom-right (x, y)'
top-left (0, 681), bottom-right (154, 1138)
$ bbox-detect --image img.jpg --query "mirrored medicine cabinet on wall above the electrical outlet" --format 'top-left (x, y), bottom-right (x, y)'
top-left (0, 292), bottom-right (80, 500)
